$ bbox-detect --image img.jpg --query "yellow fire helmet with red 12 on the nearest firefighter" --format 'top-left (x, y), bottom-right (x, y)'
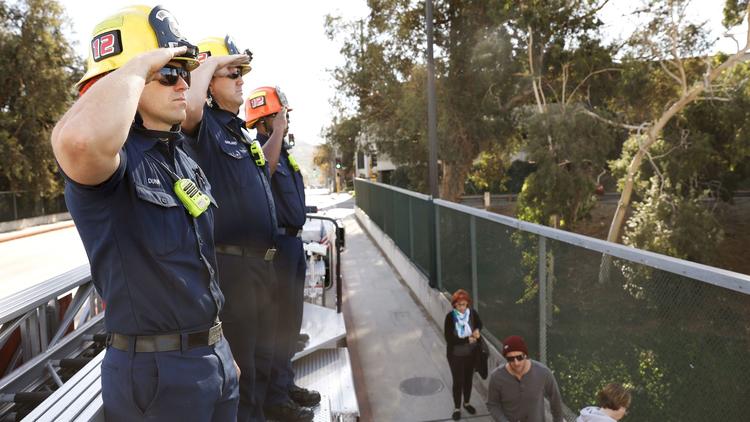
top-left (76, 6), bottom-right (200, 89)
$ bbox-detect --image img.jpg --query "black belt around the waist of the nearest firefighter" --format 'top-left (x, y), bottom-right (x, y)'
top-left (107, 322), bottom-right (222, 353)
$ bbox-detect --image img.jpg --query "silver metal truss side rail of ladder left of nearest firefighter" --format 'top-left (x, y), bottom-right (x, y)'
top-left (0, 265), bottom-right (104, 416)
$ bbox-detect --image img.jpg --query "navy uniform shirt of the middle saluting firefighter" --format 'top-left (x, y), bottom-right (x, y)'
top-left (186, 106), bottom-right (276, 249)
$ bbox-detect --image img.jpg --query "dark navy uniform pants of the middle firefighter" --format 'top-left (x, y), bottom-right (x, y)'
top-left (216, 254), bottom-right (278, 422)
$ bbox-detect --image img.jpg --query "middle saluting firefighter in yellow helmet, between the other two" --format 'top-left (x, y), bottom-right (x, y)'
top-left (182, 36), bottom-right (314, 421)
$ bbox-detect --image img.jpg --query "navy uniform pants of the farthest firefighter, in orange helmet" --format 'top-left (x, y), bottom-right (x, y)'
top-left (265, 235), bottom-right (306, 405)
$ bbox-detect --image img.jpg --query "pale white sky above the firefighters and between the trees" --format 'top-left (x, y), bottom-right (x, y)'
top-left (61, 0), bottom-right (742, 152)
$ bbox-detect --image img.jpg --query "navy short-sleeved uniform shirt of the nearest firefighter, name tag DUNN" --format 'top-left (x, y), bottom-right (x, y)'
top-left (65, 124), bottom-right (224, 335)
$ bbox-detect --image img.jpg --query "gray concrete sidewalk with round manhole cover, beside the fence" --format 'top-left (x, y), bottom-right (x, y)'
top-left (341, 217), bottom-right (491, 421)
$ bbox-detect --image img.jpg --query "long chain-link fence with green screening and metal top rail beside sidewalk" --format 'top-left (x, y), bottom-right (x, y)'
top-left (357, 181), bottom-right (750, 422)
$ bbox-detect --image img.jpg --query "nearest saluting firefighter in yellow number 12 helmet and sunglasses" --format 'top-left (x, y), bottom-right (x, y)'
top-left (52, 6), bottom-right (239, 422)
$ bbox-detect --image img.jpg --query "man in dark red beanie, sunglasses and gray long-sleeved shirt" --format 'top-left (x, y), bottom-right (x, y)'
top-left (487, 336), bottom-right (563, 422)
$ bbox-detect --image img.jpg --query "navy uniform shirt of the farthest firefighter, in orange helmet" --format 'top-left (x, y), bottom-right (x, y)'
top-left (258, 133), bottom-right (306, 229)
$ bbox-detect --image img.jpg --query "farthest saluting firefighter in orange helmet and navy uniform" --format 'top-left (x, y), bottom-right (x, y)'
top-left (245, 87), bottom-right (320, 414)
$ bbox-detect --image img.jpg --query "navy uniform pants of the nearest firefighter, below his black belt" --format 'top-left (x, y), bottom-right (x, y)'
top-left (101, 339), bottom-right (239, 422)
